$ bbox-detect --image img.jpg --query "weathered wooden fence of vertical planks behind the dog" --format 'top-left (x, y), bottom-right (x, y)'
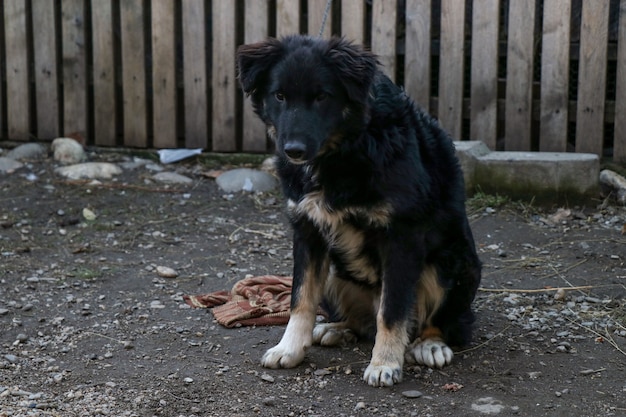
top-left (0, 0), bottom-right (626, 161)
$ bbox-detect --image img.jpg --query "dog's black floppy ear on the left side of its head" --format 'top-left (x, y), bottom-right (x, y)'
top-left (237, 38), bottom-right (284, 99)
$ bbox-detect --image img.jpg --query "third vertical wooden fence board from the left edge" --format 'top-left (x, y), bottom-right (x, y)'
top-left (61, 0), bottom-right (87, 139)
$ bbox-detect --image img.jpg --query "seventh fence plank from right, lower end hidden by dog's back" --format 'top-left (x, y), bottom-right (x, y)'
top-left (404, 0), bottom-right (432, 111)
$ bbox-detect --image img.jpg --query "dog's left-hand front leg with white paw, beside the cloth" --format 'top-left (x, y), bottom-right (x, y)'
top-left (261, 224), bottom-right (329, 368)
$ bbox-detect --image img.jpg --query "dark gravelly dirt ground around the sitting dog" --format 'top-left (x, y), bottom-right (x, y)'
top-left (0, 153), bottom-right (626, 417)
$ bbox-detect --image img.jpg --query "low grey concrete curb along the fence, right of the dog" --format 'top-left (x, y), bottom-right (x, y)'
top-left (454, 141), bottom-right (600, 204)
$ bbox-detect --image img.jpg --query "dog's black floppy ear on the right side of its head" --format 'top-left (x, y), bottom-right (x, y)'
top-left (327, 38), bottom-right (378, 105)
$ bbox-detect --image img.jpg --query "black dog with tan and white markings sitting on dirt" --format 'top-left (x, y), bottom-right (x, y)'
top-left (237, 36), bottom-right (480, 386)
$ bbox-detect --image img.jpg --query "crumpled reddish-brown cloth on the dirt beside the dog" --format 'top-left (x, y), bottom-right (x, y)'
top-left (183, 275), bottom-right (292, 327)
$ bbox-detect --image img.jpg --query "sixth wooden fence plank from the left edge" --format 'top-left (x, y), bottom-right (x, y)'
top-left (152, 0), bottom-right (177, 148)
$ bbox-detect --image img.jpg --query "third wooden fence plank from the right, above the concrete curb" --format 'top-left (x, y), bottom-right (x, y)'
top-left (539, 0), bottom-right (571, 152)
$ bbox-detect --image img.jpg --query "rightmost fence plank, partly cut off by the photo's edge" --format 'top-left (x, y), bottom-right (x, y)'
top-left (613, 0), bottom-right (626, 162)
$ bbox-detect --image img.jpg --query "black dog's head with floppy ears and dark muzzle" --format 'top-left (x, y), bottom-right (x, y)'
top-left (237, 36), bottom-right (378, 164)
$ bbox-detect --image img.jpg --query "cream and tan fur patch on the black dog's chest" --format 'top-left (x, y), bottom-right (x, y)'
top-left (288, 191), bottom-right (391, 284)
